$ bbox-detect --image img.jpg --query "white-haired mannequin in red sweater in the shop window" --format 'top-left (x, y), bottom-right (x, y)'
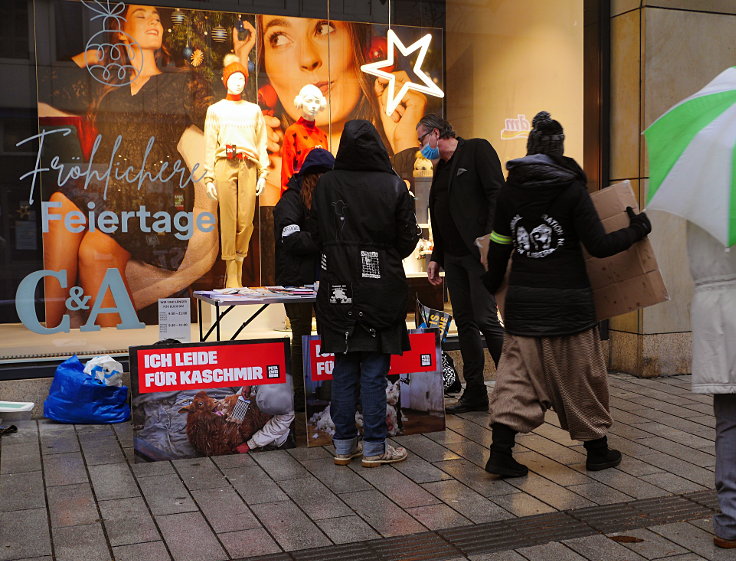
top-left (281, 84), bottom-right (327, 194)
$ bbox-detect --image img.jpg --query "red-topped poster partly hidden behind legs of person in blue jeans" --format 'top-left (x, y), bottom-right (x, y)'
top-left (303, 330), bottom-right (445, 446)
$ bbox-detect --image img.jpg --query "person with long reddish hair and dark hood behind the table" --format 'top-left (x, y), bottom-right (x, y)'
top-left (273, 148), bottom-right (335, 411)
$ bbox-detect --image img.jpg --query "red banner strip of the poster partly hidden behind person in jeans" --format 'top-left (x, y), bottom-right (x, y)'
top-left (309, 332), bottom-right (438, 382)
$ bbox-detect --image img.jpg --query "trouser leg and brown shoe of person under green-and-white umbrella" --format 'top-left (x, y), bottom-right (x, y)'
top-left (713, 393), bottom-right (736, 540)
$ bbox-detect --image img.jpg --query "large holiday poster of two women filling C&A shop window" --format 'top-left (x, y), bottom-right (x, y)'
top-left (21, 0), bottom-right (443, 334)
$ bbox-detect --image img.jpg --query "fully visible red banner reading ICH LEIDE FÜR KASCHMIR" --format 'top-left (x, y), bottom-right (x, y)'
top-left (131, 341), bottom-right (286, 393)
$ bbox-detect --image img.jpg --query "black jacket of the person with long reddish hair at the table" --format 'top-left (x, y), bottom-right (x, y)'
top-left (273, 174), bottom-right (319, 286)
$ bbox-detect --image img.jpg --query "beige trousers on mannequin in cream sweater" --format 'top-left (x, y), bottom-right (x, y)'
top-left (215, 158), bottom-right (258, 261)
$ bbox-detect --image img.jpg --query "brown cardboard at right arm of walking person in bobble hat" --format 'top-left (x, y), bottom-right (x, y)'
top-left (585, 180), bottom-right (669, 320)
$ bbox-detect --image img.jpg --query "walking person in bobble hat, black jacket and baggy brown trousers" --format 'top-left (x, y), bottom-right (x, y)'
top-left (483, 111), bottom-right (651, 477)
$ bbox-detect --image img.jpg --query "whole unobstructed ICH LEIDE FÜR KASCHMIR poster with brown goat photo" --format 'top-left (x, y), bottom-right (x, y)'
top-left (130, 339), bottom-right (294, 462)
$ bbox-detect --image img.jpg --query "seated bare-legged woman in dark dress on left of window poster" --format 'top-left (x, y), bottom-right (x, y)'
top-left (39, 4), bottom-right (255, 327)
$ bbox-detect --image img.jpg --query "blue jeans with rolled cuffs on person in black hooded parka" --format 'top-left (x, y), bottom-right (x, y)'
top-left (330, 352), bottom-right (391, 456)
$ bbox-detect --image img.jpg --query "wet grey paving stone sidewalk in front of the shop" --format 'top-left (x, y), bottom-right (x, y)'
top-left (0, 374), bottom-right (724, 561)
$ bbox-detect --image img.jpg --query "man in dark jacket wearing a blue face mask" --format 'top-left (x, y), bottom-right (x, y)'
top-left (417, 114), bottom-right (503, 413)
